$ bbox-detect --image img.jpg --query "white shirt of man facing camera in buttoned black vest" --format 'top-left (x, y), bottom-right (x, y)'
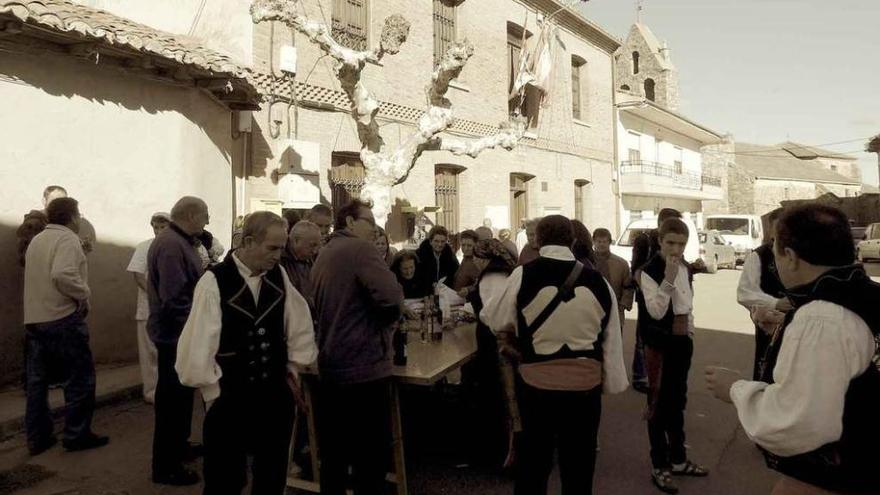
top-left (174, 255), bottom-right (318, 402)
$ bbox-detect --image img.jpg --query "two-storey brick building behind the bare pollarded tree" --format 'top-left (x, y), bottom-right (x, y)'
top-left (241, 0), bottom-right (619, 243)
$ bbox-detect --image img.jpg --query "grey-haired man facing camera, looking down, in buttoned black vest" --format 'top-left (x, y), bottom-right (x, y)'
top-left (176, 212), bottom-right (317, 495)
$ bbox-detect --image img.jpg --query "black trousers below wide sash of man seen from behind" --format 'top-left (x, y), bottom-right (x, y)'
top-left (513, 380), bottom-right (602, 495)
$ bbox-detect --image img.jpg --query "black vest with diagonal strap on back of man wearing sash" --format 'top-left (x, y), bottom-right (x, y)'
top-left (516, 257), bottom-right (612, 363)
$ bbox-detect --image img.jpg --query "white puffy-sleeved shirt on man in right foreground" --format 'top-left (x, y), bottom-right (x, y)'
top-left (730, 301), bottom-right (874, 457)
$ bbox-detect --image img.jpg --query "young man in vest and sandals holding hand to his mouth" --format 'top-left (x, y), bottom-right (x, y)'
top-left (639, 218), bottom-right (708, 493)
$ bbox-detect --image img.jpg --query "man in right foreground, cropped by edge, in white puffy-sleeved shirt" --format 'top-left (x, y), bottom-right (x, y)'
top-left (706, 204), bottom-right (880, 495)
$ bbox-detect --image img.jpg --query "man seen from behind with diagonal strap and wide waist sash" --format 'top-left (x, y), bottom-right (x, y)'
top-left (480, 215), bottom-right (627, 495)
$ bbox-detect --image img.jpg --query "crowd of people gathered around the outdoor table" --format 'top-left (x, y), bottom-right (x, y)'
top-left (19, 186), bottom-right (880, 495)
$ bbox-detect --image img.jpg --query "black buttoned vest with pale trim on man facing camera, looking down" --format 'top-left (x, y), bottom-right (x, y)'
top-left (210, 256), bottom-right (287, 392)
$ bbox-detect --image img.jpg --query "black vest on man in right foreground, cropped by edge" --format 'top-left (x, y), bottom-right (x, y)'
top-left (761, 265), bottom-right (880, 493)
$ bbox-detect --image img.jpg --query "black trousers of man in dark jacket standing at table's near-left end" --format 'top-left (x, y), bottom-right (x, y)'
top-left (316, 378), bottom-right (391, 495)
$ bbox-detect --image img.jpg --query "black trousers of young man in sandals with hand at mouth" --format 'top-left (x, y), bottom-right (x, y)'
top-left (648, 335), bottom-right (694, 469)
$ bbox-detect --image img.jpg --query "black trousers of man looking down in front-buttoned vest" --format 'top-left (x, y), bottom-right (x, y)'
top-left (203, 377), bottom-right (294, 495)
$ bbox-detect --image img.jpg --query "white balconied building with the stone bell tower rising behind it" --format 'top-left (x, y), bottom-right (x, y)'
top-left (615, 23), bottom-right (722, 232)
